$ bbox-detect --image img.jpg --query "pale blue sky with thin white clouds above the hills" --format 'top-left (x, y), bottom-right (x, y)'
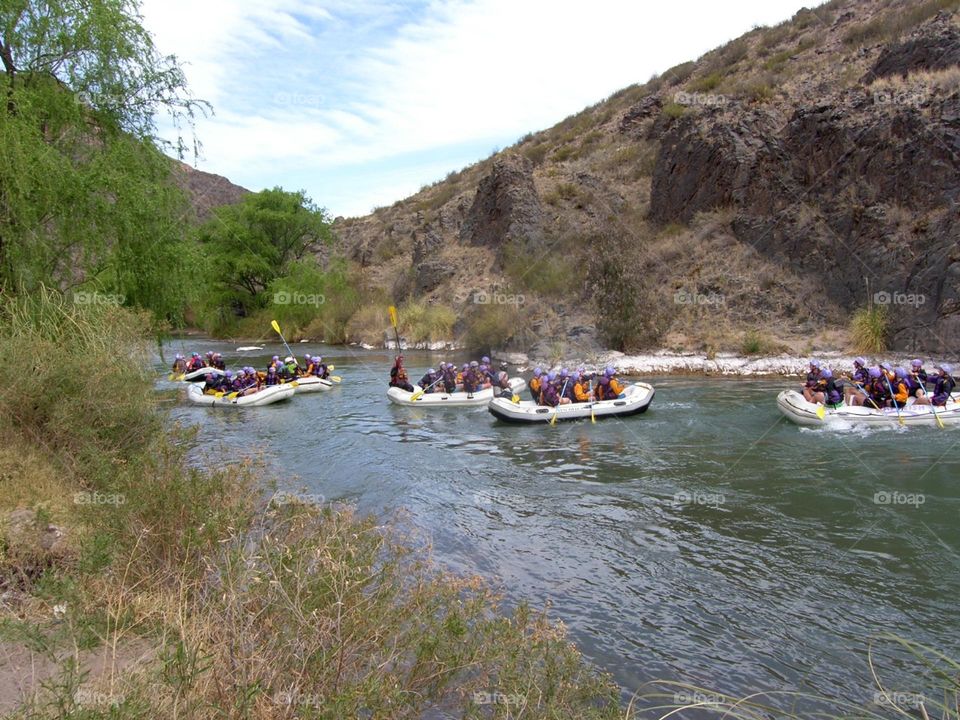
top-left (141, 0), bottom-right (813, 217)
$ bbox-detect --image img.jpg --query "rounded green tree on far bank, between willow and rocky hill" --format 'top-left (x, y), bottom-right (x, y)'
top-left (193, 188), bottom-right (333, 317)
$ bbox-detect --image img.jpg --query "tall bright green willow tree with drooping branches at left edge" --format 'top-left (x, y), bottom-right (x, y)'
top-left (0, 0), bottom-right (206, 319)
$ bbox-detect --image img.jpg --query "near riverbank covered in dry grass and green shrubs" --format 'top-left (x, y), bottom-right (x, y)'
top-left (0, 292), bottom-right (624, 720)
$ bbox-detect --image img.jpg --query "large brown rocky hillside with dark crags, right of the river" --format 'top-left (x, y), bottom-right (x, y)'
top-left (335, 0), bottom-right (960, 357)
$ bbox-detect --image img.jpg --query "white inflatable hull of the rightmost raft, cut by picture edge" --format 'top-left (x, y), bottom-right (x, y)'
top-left (777, 390), bottom-right (960, 427)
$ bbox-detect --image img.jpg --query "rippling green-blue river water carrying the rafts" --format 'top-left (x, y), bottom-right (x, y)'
top-left (157, 340), bottom-right (960, 702)
